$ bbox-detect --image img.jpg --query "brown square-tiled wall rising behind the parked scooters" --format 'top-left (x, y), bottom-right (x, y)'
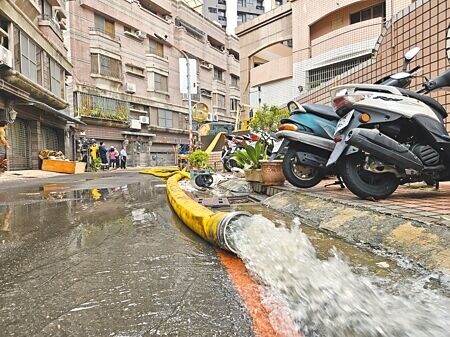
top-left (300, 0), bottom-right (450, 130)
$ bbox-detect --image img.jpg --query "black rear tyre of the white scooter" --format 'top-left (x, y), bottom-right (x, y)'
top-left (338, 153), bottom-right (400, 200)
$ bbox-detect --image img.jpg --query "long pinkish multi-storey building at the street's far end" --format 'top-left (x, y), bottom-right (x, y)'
top-left (69, 0), bottom-right (240, 166)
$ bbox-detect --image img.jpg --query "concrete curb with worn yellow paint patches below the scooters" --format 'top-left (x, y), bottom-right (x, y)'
top-left (253, 184), bottom-right (450, 273)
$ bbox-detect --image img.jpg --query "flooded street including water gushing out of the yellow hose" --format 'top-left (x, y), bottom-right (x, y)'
top-left (0, 172), bottom-right (450, 337)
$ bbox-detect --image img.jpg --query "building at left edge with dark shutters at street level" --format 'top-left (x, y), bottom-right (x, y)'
top-left (0, 0), bottom-right (78, 170)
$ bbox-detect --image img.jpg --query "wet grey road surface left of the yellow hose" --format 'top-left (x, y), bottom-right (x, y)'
top-left (0, 172), bottom-right (253, 337)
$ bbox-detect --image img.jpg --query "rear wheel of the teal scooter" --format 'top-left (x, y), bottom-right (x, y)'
top-left (283, 148), bottom-right (324, 188)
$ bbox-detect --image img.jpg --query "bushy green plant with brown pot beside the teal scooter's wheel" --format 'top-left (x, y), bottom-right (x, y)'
top-left (250, 104), bottom-right (289, 185)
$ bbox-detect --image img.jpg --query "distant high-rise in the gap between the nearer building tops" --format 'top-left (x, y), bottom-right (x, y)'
top-left (200, 0), bottom-right (287, 34)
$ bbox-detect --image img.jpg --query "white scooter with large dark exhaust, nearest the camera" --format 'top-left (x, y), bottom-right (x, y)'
top-left (327, 65), bottom-right (450, 199)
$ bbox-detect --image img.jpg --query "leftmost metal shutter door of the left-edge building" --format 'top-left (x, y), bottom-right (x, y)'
top-left (8, 118), bottom-right (31, 170)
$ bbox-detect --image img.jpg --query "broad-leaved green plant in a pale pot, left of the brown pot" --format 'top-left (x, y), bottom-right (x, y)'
top-left (232, 140), bottom-right (267, 182)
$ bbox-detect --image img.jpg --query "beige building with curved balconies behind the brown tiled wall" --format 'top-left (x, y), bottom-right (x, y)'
top-left (237, 0), bottom-right (416, 106)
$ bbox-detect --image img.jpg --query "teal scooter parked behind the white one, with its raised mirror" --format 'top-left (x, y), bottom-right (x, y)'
top-left (276, 47), bottom-right (420, 188)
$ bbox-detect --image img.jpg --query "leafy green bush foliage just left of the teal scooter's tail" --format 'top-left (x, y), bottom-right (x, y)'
top-left (249, 104), bottom-right (289, 133)
